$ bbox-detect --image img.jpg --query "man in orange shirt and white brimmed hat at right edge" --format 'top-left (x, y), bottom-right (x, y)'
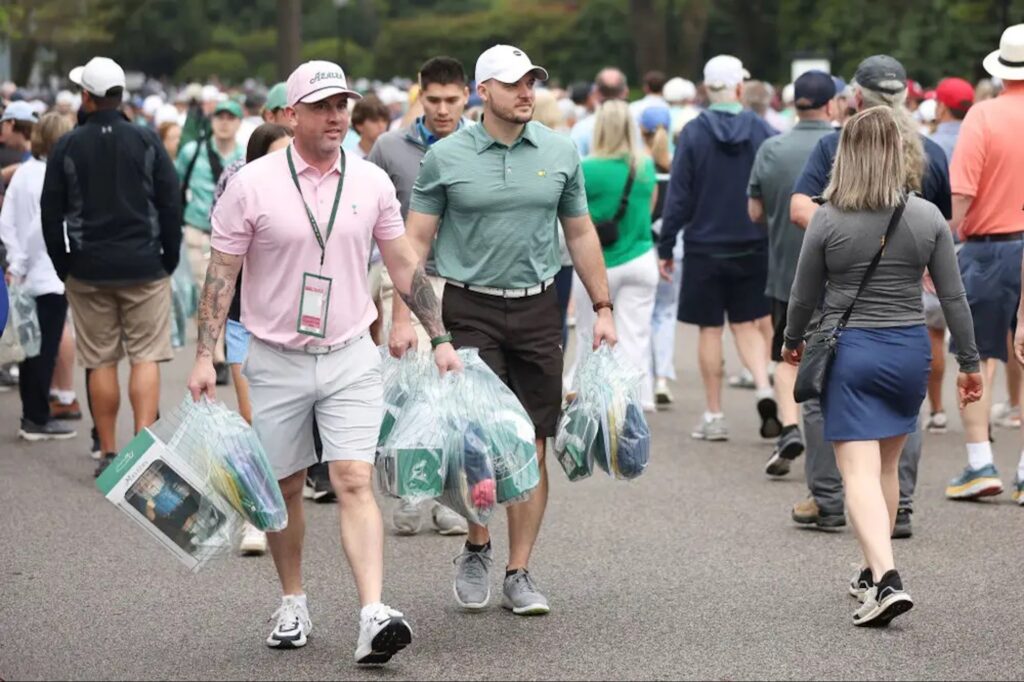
top-left (946, 24), bottom-right (1024, 506)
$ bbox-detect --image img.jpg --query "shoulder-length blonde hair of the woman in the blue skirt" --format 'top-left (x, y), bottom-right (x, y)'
top-left (822, 106), bottom-right (916, 211)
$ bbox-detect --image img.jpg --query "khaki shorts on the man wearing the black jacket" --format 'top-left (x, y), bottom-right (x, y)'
top-left (65, 276), bottom-right (174, 370)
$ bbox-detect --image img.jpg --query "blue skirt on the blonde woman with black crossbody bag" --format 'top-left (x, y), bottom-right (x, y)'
top-left (821, 325), bottom-right (932, 440)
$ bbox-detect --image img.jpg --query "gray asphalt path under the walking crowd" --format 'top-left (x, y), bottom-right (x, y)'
top-left (0, 332), bottom-right (1024, 680)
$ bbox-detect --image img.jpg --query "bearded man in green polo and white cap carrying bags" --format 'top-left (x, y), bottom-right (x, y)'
top-left (390, 45), bottom-right (616, 615)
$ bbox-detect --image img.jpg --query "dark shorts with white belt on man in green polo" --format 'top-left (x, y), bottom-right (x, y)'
top-left (441, 285), bottom-right (562, 439)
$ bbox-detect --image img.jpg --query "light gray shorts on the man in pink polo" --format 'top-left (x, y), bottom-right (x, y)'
top-left (242, 334), bottom-right (384, 480)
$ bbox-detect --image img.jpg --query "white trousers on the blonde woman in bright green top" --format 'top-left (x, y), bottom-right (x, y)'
top-left (569, 250), bottom-right (658, 408)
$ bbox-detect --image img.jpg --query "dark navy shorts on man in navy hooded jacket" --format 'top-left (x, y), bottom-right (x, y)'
top-left (679, 251), bottom-right (771, 327)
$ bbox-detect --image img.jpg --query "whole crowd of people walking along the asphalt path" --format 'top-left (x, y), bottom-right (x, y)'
top-left (0, 19), bottom-right (1024, 665)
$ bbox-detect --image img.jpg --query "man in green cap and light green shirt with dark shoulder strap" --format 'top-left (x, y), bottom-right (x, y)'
top-left (175, 99), bottom-right (246, 386)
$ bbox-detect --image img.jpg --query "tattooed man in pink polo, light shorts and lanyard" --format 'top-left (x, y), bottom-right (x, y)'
top-left (188, 61), bottom-right (462, 665)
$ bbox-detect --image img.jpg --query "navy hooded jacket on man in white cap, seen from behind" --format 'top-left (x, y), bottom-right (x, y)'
top-left (657, 110), bottom-right (777, 259)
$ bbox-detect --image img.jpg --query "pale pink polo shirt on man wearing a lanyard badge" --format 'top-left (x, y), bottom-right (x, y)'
top-left (211, 143), bottom-right (406, 348)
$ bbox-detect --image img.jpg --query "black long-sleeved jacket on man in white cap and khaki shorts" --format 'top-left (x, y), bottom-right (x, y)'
top-left (40, 111), bottom-right (181, 283)
